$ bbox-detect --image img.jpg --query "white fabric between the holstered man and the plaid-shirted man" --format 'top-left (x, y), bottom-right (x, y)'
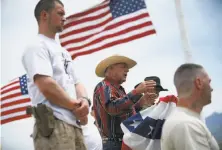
top-left (82, 114), bottom-right (103, 150)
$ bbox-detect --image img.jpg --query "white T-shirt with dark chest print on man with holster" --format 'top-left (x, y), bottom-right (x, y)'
top-left (22, 34), bottom-right (79, 127)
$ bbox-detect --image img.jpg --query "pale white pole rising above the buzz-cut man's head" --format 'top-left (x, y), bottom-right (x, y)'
top-left (175, 0), bottom-right (192, 63)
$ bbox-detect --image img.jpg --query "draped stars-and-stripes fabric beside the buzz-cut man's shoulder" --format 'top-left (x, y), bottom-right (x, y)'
top-left (121, 95), bottom-right (177, 150)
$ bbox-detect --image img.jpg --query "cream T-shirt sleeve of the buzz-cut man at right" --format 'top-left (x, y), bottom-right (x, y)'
top-left (170, 122), bottom-right (210, 150)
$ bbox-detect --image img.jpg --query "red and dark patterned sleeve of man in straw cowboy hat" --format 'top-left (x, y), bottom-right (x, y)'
top-left (97, 85), bottom-right (139, 116)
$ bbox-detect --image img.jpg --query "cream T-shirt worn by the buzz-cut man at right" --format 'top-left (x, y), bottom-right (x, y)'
top-left (161, 107), bottom-right (219, 150)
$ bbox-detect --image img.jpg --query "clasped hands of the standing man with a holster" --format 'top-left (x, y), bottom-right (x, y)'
top-left (72, 99), bottom-right (89, 120)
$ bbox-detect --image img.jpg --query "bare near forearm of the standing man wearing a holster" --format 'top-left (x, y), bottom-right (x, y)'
top-left (35, 77), bottom-right (75, 110)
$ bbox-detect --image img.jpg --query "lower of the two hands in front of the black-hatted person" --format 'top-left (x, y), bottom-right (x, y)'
top-left (139, 93), bottom-right (158, 107)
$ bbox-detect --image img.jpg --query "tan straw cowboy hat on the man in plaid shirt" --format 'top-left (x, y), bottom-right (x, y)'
top-left (96, 55), bottom-right (137, 77)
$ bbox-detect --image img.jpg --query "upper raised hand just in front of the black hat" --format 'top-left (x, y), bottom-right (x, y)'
top-left (135, 80), bottom-right (156, 94)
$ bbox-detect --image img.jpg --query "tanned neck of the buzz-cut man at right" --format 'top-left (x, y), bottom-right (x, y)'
top-left (177, 94), bottom-right (203, 114)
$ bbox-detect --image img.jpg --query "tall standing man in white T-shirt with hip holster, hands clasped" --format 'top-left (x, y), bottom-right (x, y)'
top-left (22, 0), bottom-right (89, 150)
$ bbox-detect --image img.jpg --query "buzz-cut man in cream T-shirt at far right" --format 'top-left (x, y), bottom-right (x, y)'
top-left (161, 64), bottom-right (219, 150)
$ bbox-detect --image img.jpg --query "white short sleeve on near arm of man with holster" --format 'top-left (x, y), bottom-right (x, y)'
top-left (22, 45), bottom-right (53, 81)
